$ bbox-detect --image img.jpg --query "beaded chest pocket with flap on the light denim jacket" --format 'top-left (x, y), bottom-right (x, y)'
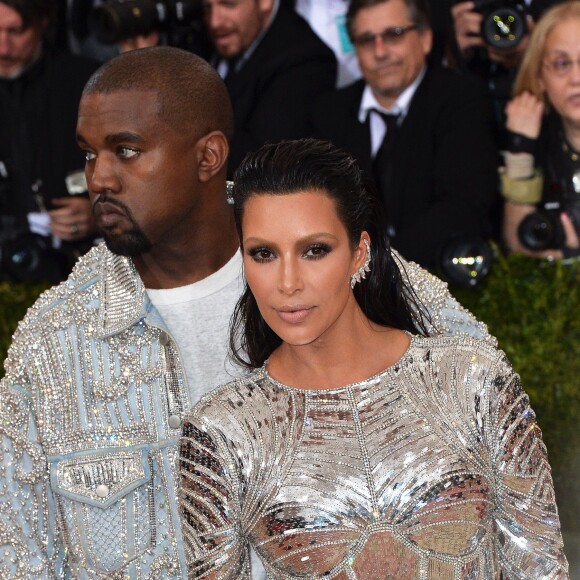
top-left (51, 449), bottom-right (155, 573)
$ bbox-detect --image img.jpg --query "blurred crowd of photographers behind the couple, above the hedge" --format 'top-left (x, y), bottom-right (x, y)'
top-left (0, 0), bottom-right (580, 285)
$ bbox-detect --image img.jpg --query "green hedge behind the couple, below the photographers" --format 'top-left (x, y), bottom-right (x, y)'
top-left (0, 256), bottom-right (580, 530)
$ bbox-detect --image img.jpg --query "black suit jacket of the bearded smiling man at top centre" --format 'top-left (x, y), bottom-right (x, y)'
top-left (226, 6), bottom-right (336, 174)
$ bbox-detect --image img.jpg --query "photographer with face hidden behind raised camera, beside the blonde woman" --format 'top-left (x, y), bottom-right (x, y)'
top-left (448, 0), bottom-right (557, 125)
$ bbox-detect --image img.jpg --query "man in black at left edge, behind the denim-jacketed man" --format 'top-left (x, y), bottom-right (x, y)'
top-left (0, 0), bottom-right (97, 282)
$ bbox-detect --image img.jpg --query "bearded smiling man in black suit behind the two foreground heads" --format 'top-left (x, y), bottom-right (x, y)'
top-left (204, 0), bottom-right (336, 174)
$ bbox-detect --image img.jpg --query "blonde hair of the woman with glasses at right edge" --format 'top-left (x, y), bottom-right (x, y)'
top-left (513, 0), bottom-right (580, 99)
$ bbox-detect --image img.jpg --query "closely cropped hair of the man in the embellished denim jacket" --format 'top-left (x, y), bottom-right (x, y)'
top-left (83, 46), bottom-right (233, 140)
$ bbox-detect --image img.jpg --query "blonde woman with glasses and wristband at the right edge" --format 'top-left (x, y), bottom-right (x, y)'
top-left (502, 0), bottom-right (580, 258)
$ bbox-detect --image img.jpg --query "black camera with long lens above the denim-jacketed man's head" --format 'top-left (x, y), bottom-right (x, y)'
top-left (89, 0), bottom-right (202, 48)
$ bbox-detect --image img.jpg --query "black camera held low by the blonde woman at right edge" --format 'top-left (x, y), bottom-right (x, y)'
top-left (518, 179), bottom-right (580, 251)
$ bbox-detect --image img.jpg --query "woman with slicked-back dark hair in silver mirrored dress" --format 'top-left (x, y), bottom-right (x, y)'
top-left (180, 140), bottom-right (567, 580)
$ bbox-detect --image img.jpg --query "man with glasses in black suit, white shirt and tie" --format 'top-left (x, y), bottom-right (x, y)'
top-left (312, 0), bottom-right (497, 268)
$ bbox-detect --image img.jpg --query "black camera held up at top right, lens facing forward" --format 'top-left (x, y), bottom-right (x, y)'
top-left (474, 0), bottom-right (527, 49)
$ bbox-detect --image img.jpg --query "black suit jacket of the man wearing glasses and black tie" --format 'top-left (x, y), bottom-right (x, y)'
top-left (312, 68), bottom-right (497, 267)
